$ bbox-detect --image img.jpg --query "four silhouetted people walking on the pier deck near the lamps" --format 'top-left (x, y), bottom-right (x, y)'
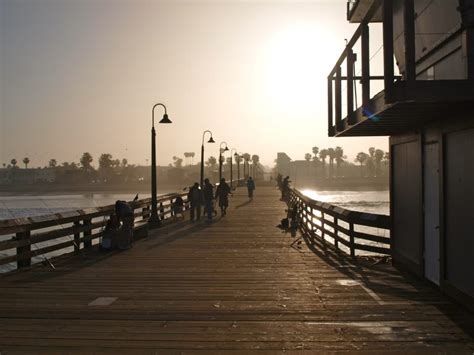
top-left (188, 177), bottom-right (255, 221)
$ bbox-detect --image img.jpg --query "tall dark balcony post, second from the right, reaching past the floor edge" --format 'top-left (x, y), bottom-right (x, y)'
top-left (383, 0), bottom-right (394, 102)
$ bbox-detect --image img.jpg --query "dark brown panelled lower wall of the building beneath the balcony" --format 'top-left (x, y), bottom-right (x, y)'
top-left (390, 114), bottom-right (474, 308)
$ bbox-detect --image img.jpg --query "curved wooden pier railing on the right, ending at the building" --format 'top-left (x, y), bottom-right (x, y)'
top-left (288, 189), bottom-right (391, 257)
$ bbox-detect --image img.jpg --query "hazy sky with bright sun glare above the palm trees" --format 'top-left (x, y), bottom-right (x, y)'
top-left (0, 0), bottom-right (387, 166)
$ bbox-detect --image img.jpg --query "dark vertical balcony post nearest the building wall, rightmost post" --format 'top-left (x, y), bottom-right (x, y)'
top-left (403, 0), bottom-right (416, 84)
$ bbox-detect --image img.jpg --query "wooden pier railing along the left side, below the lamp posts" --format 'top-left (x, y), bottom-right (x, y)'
top-left (0, 193), bottom-right (188, 269)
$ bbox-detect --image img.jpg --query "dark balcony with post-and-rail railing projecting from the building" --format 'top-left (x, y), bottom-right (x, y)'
top-left (327, 0), bottom-right (474, 136)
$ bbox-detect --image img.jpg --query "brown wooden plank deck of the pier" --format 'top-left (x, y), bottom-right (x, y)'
top-left (0, 187), bottom-right (474, 355)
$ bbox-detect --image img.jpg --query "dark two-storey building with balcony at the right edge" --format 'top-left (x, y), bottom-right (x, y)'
top-left (328, 0), bottom-right (474, 307)
